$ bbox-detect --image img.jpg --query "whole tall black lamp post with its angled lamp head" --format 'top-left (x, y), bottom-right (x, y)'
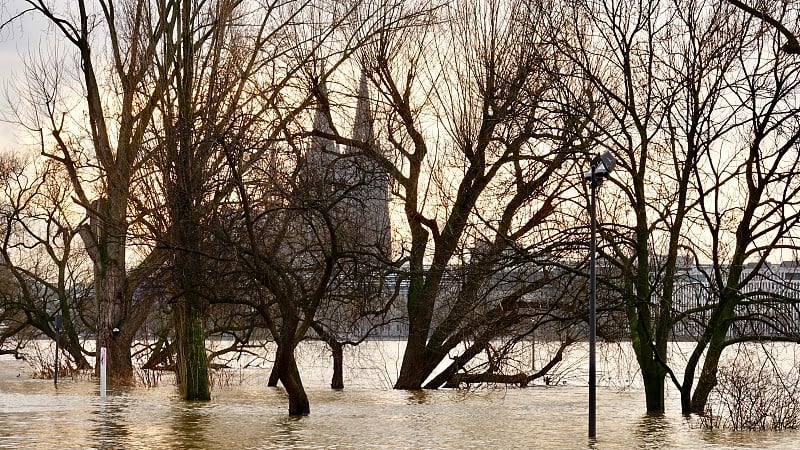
top-left (583, 150), bottom-right (617, 438)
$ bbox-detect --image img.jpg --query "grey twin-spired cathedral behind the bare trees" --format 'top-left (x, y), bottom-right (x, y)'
top-left (300, 75), bottom-right (396, 337)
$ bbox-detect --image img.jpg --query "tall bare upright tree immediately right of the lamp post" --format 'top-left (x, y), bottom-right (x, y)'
top-left (565, 2), bottom-right (756, 411)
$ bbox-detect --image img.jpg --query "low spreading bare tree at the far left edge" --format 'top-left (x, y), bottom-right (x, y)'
top-left (0, 156), bottom-right (95, 370)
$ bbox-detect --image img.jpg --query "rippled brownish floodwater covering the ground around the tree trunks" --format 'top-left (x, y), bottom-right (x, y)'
top-left (0, 342), bottom-right (800, 449)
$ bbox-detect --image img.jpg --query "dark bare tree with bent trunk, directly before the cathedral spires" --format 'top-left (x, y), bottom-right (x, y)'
top-left (206, 2), bottom-right (394, 415)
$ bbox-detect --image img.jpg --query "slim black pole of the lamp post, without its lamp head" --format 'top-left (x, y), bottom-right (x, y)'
top-left (589, 171), bottom-right (598, 438)
